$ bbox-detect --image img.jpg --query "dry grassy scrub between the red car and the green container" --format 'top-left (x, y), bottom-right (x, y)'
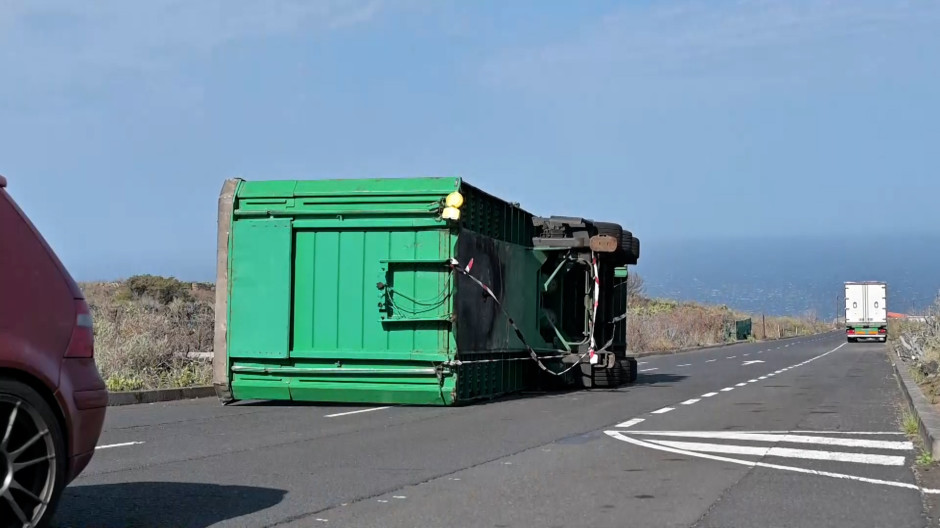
top-left (81, 282), bottom-right (214, 391)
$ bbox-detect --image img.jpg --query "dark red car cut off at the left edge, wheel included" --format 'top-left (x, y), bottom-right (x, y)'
top-left (0, 176), bottom-right (108, 528)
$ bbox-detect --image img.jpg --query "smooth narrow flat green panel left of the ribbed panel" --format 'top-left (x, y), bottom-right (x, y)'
top-left (229, 219), bottom-right (291, 358)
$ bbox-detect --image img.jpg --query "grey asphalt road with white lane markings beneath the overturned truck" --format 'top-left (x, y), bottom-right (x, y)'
top-left (49, 333), bottom-right (930, 528)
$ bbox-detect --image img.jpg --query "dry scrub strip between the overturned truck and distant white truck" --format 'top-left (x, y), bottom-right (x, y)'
top-left (627, 296), bottom-right (833, 352)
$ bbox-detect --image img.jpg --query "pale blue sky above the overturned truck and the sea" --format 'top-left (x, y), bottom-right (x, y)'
top-left (0, 0), bottom-right (940, 279)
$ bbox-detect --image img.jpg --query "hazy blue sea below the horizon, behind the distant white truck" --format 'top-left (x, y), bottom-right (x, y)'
top-left (635, 233), bottom-right (940, 319)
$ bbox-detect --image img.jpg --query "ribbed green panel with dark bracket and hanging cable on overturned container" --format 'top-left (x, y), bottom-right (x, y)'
top-left (291, 228), bottom-right (452, 361)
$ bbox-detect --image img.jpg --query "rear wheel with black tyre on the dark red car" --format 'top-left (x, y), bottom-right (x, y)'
top-left (0, 378), bottom-right (68, 528)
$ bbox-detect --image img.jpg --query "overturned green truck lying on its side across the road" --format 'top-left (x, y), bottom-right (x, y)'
top-left (213, 178), bottom-right (639, 405)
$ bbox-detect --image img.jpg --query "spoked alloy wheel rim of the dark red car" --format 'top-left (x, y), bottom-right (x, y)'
top-left (0, 394), bottom-right (57, 528)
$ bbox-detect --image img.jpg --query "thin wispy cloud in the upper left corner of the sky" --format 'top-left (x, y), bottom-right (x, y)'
top-left (0, 0), bottom-right (383, 95)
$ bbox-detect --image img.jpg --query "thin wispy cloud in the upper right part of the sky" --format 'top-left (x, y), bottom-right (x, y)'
top-left (483, 0), bottom-right (940, 95)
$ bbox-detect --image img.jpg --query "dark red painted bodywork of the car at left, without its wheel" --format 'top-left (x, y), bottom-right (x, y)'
top-left (0, 177), bottom-right (108, 524)
